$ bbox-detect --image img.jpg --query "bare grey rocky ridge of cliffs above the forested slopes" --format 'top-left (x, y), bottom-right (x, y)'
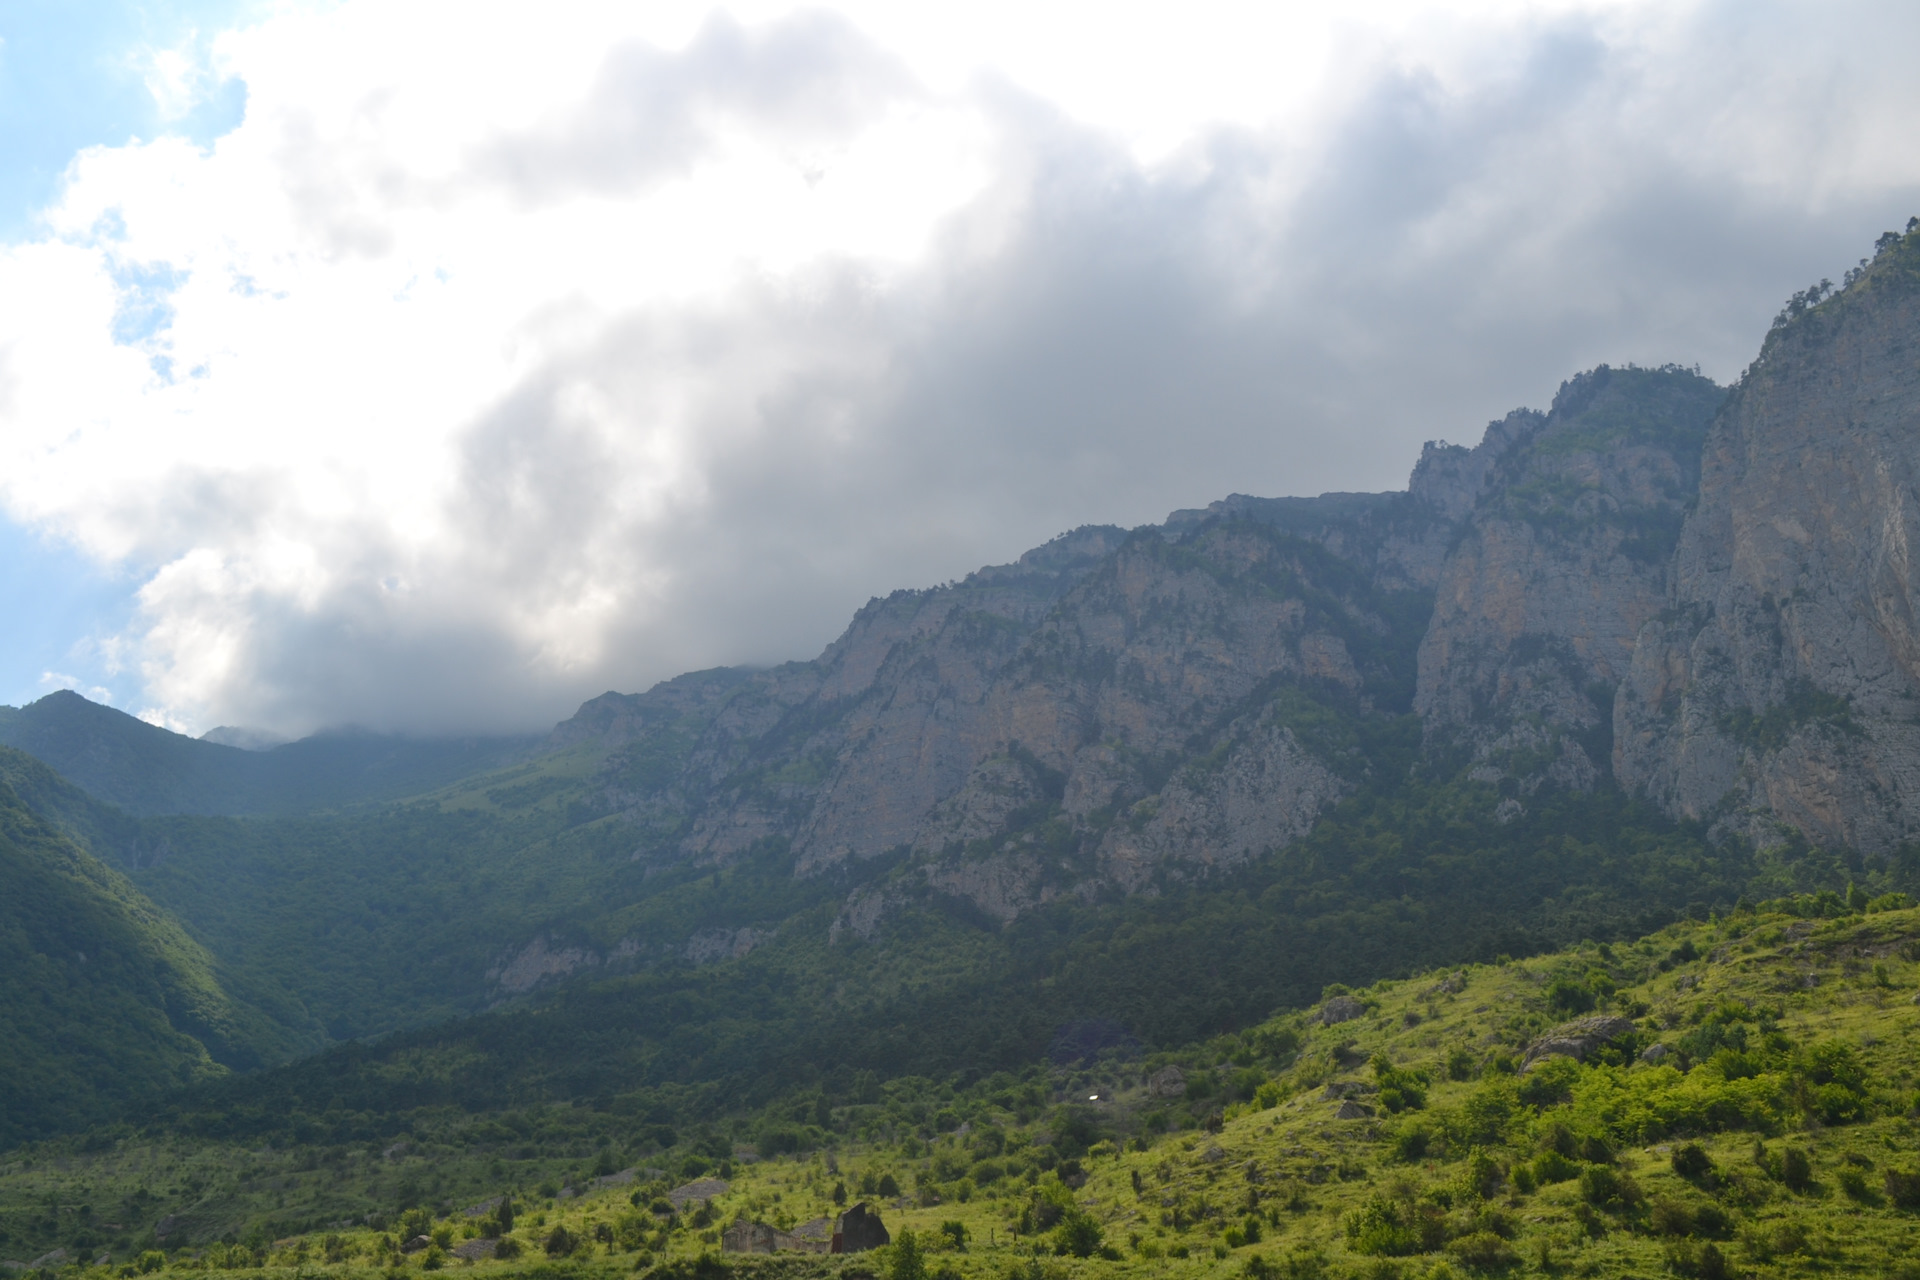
top-left (529, 222), bottom-right (1920, 951)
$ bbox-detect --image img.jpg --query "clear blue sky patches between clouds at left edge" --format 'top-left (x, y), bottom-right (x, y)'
top-left (0, 0), bottom-right (250, 706)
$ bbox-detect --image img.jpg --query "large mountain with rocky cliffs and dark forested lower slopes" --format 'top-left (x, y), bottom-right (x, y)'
top-left (4, 230), bottom-right (1920, 1182)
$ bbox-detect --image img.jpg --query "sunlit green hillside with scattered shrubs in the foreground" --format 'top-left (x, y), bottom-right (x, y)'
top-left (0, 892), bottom-right (1920, 1280)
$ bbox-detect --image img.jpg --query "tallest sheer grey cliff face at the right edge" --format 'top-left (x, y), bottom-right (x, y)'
top-left (1615, 232), bottom-right (1920, 850)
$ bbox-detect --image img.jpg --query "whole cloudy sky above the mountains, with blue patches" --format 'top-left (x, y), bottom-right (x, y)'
top-left (0, 0), bottom-right (1920, 735)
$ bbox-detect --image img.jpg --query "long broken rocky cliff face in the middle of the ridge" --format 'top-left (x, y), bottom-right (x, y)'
top-left (549, 466), bottom-right (1482, 929)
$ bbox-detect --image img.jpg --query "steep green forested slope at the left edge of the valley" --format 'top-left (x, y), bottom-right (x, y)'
top-left (0, 748), bottom-right (313, 1144)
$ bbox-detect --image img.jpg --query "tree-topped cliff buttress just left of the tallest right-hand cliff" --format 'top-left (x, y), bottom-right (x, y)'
top-left (1413, 365), bottom-right (1724, 793)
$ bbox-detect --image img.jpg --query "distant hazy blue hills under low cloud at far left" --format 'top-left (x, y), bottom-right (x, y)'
top-left (0, 691), bottom-right (538, 816)
